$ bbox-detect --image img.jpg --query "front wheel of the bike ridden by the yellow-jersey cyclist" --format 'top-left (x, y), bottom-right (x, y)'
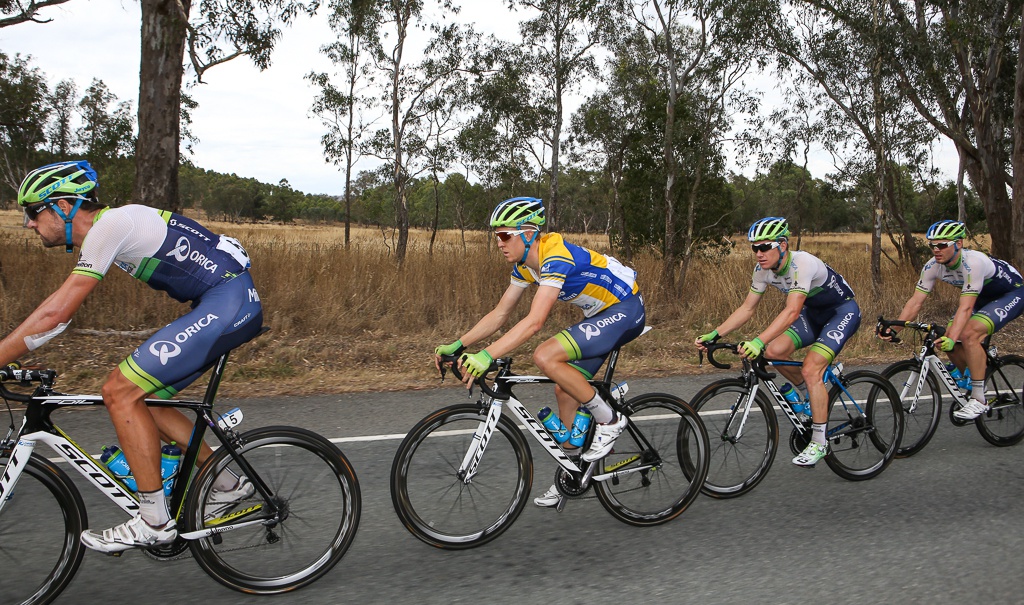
top-left (391, 403), bottom-right (534, 549)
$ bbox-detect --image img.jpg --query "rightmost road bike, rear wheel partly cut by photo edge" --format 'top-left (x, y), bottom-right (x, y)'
top-left (877, 316), bottom-right (1024, 457)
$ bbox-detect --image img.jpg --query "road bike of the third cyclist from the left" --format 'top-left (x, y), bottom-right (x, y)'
top-left (691, 343), bottom-right (903, 499)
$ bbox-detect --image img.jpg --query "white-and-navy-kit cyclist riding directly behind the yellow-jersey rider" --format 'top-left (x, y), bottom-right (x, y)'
top-left (695, 216), bottom-right (860, 467)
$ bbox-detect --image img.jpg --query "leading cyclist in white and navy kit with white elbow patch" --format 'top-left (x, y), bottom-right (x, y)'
top-left (0, 161), bottom-right (263, 553)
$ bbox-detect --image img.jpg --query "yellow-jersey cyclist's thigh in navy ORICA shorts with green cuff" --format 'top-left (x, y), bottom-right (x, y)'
top-left (553, 296), bottom-right (647, 378)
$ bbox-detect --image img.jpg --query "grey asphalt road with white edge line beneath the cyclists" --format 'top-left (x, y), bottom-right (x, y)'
top-left (6, 373), bottom-right (1024, 605)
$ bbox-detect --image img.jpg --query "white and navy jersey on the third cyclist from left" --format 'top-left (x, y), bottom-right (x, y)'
top-left (751, 250), bottom-right (854, 309)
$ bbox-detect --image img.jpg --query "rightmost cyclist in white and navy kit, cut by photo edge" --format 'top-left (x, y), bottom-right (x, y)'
top-left (879, 220), bottom-right (1024, 420)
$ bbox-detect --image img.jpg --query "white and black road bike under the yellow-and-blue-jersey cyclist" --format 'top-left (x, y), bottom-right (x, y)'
top-left (391, 337), bottom-right (708, 549)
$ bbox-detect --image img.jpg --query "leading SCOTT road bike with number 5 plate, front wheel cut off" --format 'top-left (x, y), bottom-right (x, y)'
top-left (0, 337), bottom-right (360, 605)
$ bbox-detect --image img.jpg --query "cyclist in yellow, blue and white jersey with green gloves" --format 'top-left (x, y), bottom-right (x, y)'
top-left (434, 198), bottom-right (646, 507)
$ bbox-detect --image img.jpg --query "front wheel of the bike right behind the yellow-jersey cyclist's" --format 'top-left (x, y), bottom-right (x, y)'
top-left (692, 378), bottom-right (778, 499)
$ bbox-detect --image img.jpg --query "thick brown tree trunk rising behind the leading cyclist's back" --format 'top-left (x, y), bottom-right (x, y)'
top-left (132, 0), bottom-right (191, 212)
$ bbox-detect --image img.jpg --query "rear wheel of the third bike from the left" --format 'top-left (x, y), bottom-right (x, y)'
top-left (825, 371), bottom-right (903, 481)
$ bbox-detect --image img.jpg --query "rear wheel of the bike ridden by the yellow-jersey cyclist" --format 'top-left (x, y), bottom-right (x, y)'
top-left (594, 393), bottom-right (709, 527)
